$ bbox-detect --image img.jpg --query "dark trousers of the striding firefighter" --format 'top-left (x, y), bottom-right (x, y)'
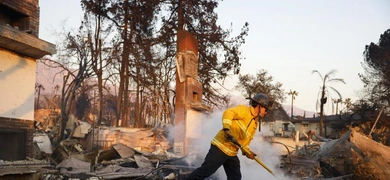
top-left (186, 145), bottom-right (241, 180)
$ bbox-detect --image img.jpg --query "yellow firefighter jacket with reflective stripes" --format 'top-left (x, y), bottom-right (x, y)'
top-left (211, 105), bottom-right (258, 156)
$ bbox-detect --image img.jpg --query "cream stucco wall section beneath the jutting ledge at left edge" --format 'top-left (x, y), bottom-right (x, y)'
top-left (0, 49), bottom-right (36, 120)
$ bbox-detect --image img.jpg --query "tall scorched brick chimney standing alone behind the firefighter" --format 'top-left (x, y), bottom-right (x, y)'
top-left (174, 30), bottom-right (210, 154)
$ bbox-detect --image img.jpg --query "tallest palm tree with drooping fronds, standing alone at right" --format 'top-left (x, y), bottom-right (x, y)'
top-left (312, 69), bottom-right (346, 136)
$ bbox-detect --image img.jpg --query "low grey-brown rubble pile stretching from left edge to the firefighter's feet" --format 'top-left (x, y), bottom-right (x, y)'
top-left (0, 131), bottom-right (193, 180)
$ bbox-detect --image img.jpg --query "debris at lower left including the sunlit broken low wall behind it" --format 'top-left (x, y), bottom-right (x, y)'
top-left (0, 125), bottom-right (193, 180)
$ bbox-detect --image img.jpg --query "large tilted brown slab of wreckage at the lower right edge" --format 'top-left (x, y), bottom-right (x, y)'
top-left (317, 129), bottom-right (390, 180)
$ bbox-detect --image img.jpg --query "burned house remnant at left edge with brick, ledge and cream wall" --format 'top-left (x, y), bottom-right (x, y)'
top-left (0, 0), bottom-right (56, 160)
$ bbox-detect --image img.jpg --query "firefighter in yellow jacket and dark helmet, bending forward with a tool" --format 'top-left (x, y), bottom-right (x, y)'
top-left (186, 93), bottom-right (272, 180)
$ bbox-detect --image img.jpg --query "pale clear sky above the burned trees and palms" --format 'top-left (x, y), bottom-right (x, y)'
top-left (39, 0), bottom-right (390, 114)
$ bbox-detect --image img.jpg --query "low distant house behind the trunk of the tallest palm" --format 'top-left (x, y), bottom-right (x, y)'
top-left (291, 114), bottom-right (361, 137)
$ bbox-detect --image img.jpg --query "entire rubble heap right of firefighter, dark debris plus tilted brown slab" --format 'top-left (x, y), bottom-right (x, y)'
top-left (281, 128), bottom-right (390, 180)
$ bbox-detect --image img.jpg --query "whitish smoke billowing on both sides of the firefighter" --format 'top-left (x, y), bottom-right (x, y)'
top-left (187, 111), bottom-right (293, 180)
